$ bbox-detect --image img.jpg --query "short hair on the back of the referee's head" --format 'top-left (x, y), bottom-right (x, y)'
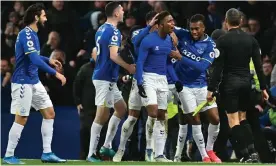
top-left (226, 8), bottom-right (242, 26)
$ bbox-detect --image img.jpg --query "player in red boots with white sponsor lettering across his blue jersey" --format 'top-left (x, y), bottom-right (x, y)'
top-left (172, 14), bottom-right (221, 162)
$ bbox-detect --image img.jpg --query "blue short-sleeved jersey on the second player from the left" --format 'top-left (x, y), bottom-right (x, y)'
top-left (92, 23), bottom-right (121, 82)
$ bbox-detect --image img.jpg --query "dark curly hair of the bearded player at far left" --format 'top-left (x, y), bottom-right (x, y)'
top-left (23, 3), bottom-right (45, 25)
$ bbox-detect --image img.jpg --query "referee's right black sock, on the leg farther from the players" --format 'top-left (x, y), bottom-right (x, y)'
top-left (240, 120), bottom-right (256, 154)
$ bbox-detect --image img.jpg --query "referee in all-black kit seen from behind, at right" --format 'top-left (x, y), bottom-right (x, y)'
top-left (207, 8), bottom-right (269, 162)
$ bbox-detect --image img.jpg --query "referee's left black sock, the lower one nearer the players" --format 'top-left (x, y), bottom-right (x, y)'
top-left (232, 125), bottom-right (249, 159)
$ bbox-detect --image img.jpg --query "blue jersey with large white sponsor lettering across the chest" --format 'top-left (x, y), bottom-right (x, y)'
top-left (174, 27), bottom-right (216, 88)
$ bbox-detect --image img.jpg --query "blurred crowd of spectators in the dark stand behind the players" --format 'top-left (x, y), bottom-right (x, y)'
top-left (1, 0), bottom-right (276, 162)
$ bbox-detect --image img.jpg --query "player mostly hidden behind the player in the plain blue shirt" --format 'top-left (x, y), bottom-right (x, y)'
top-left (113, 11), bottom-right (160, 162)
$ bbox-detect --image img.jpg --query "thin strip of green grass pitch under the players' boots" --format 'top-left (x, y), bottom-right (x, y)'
top-left (1, 159), bottom-right (276, 166)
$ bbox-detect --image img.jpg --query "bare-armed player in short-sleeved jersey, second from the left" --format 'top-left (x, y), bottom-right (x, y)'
top-left (87, 2), bottom-right (135, 162)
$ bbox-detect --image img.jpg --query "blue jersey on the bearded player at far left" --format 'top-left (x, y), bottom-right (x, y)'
top-left (11, 27), bottom-right (40, 84)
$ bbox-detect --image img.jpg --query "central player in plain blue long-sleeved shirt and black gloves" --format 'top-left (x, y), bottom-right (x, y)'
top-left (136, 11), bottom-right (174, 162)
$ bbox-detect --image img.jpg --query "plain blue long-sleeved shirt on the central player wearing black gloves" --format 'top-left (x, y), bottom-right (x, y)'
top-left (136, 31), bottom-right (173, 85)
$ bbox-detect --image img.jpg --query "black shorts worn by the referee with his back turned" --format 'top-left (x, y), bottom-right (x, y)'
top-left (220, 77), bottom-right (251, 114)
